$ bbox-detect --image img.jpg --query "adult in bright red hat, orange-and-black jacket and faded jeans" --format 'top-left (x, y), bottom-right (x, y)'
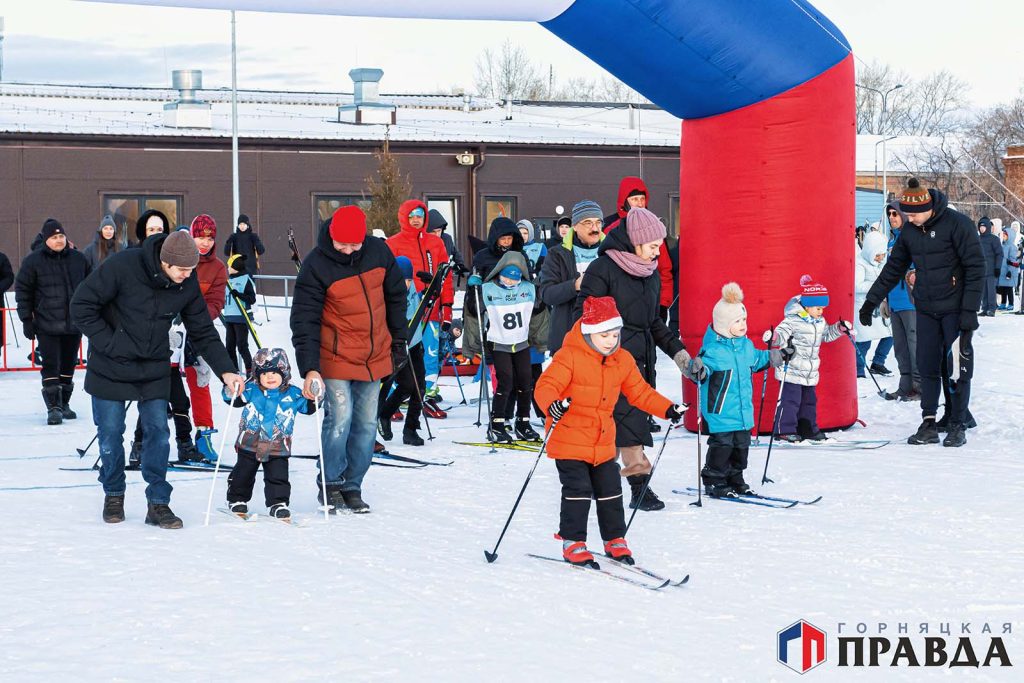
top-left (291, 206), bottom-right (408, 513)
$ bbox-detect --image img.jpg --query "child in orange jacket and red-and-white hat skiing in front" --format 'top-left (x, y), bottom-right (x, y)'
top-left (534, 297), bottom-right (685, 565)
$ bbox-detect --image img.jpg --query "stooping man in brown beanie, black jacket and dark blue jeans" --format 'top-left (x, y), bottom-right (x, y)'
top-left (71, 231), bottom-right (244, 528)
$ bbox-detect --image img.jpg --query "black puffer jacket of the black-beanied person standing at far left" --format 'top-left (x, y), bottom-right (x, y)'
top-left (14, 244), bottom-right (89, 335)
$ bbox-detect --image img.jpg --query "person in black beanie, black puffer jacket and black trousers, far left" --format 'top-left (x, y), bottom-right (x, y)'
top-left (14, 218), bottom-right (89, 425)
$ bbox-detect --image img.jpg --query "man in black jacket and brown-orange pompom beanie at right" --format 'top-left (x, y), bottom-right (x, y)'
top-left (859, 178), bottom-right (985, 447)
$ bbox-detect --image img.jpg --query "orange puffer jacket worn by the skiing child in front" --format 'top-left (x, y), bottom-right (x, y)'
top-left (534, 321), bottom-right (672, 466)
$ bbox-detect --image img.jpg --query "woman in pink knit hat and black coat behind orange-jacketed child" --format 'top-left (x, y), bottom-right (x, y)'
top-left (575, 209), bottom-right (701, 510)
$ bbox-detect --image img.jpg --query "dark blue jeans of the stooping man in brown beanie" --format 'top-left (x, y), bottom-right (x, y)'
top-left (92, 396), bottom-right (171, 505)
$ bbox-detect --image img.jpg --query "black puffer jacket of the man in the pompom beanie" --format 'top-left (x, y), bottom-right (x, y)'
top-left (866, 189), bottom-right (986, 313)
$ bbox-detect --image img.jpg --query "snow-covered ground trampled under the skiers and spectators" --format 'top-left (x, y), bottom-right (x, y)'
top-left (0, 309), bottom-right (1024, 681)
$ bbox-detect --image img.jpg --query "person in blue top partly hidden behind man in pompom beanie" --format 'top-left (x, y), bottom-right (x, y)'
top-left (885, 202), bottom-right (921, 400)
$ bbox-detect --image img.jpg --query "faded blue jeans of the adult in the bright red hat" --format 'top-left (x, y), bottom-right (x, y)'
top-left (321, 379), bottom-right (380, 490)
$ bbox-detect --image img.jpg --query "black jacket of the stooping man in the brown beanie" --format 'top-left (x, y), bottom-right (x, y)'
top-left (71, 234), bottom-right (236, 401)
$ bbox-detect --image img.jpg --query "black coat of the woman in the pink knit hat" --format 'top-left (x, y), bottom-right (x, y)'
top-left (573, 225), bottom-right (684, 447)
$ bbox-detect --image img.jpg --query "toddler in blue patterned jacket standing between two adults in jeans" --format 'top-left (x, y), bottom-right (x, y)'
top-left (222, 348), bottom-right (316, 519)
